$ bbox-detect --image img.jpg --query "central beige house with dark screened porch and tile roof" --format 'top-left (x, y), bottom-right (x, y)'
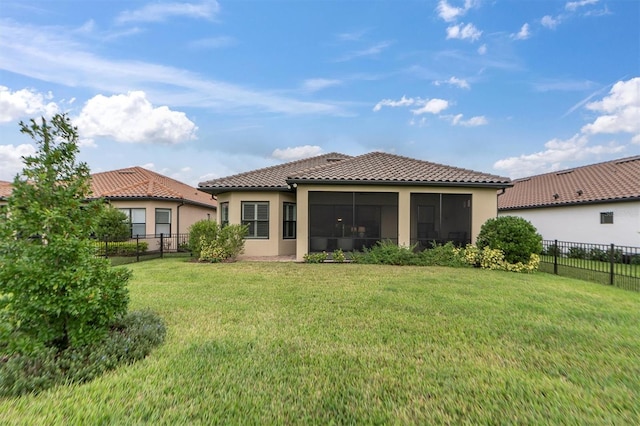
top-left (198, 152), bottom-right (511, 261)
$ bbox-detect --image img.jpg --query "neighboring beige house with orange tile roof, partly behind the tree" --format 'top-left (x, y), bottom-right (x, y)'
top-left (0, 167), bottom-right (217, 236)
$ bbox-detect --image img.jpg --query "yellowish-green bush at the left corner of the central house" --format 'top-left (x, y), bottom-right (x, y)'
top-left (198, 225), bottom-right (249, 262)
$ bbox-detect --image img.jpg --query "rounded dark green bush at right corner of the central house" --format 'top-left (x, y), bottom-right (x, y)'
top-left (476, 216), bottom-right (542, 264)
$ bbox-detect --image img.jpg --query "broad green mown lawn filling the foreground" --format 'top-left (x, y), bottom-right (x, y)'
top-left (0, 258), bottom-right (640, 424)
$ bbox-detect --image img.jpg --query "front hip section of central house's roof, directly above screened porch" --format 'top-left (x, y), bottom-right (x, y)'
top-left (288, 152), bottom-right (511, 188)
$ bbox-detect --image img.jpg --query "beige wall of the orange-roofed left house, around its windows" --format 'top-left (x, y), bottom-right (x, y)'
top-left (105, 200), bottom-right (216, 235)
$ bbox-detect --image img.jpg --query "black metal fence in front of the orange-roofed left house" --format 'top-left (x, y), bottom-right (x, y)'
top-left (95, 234), bottom-right (191, 265)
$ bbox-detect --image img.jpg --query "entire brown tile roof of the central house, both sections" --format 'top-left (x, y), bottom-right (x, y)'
top-left (199, 152), bottom-right (511, 193)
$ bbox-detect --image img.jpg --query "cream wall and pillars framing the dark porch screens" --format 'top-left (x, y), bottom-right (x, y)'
top-left (295, 185), bottom-right (498, 261)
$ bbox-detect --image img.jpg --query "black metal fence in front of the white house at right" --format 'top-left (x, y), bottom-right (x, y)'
top-left (540, 240), bottom-right (640, 291)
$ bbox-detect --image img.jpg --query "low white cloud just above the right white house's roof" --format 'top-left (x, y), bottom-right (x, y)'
top-left (493, 134), bottom-right (624, 178)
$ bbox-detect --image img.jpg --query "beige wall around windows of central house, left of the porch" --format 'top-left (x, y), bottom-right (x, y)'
top-left (217, 191), bottom-right (300, 259)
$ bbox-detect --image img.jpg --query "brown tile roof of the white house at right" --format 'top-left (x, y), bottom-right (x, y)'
top-left (498, 155), bottom-right (640, 210)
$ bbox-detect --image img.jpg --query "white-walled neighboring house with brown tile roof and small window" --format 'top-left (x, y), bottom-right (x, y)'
top-left (498, 156), bottom-right (640, 247)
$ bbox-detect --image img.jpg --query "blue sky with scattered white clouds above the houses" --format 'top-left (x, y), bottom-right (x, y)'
top-left (0, 0), bottom-right (640, 185)
